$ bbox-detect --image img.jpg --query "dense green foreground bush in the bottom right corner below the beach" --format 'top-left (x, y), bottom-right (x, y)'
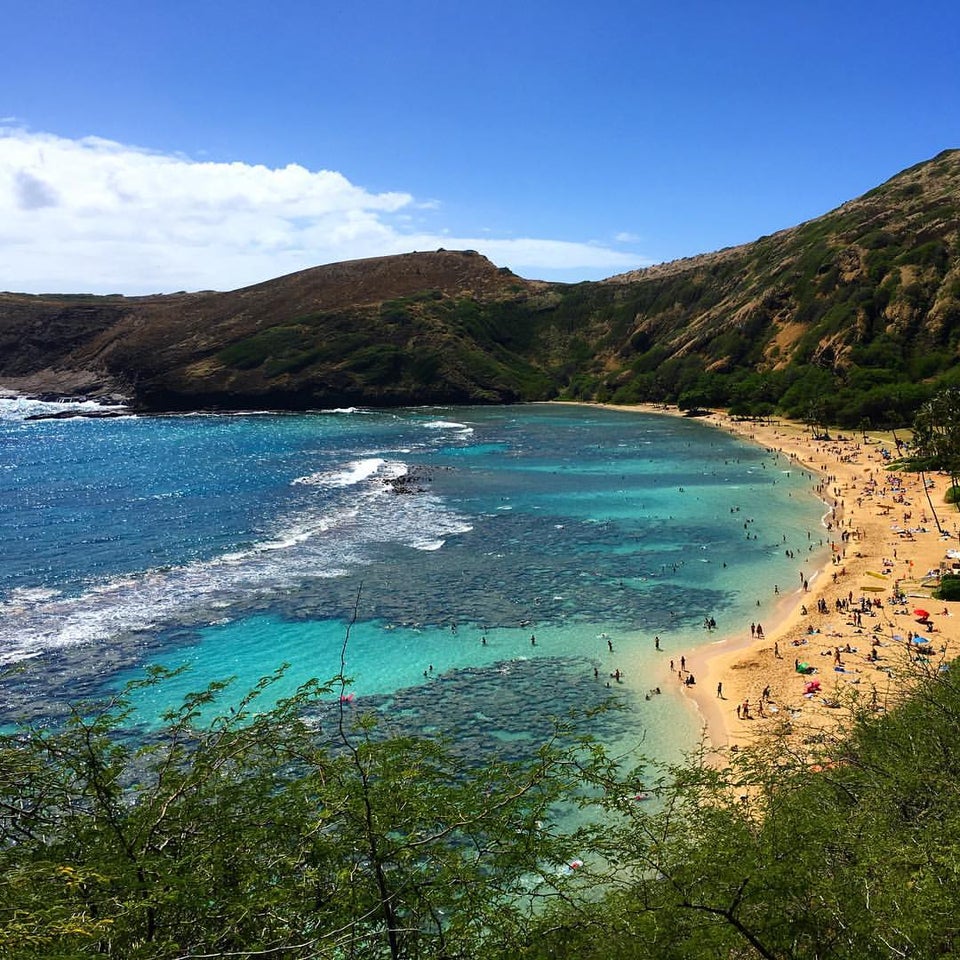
top-left (522, 675), bottom-right (960, 960)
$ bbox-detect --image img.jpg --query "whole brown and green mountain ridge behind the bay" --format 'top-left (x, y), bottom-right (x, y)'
top-left (0, 150), bottom-right (960, 423)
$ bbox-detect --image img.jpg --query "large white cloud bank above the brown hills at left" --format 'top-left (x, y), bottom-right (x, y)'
top-left (0, 127), bottom-right (639, 294)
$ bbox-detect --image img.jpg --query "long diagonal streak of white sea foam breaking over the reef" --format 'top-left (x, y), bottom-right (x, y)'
top-left (0, 458), bottom-right (472, 663)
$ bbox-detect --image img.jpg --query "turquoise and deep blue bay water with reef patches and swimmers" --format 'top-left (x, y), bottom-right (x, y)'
top-left (0, 401), bottom-right (823, 755)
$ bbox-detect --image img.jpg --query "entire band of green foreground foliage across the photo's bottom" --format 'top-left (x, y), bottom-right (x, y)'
top-left (0, 656), bottom-right (960, 960)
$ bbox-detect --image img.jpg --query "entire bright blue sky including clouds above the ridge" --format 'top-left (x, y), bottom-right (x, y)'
top-left (0, 0), bottom-right (960, 294)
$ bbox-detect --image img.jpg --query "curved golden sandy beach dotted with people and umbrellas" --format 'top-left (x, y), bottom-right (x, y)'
top-left (618, 406), bottom-right (960, 755)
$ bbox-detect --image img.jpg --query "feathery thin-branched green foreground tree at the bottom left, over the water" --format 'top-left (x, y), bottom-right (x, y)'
top-left (0, 670), bottom-right (601, 960)
